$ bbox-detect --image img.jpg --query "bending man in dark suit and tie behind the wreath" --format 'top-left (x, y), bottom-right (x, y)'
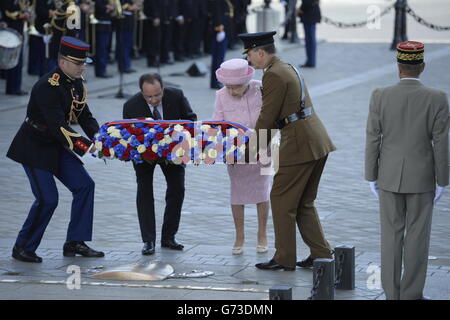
top-left (123, 74), bottom-right (197, 255)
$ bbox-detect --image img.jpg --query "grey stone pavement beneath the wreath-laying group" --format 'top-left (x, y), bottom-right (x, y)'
top-left (0, 1), bottom-right (450, 300)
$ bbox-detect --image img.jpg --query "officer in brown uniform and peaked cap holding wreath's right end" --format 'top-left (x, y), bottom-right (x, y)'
top-left (239, 32), bottom-right (336, 270)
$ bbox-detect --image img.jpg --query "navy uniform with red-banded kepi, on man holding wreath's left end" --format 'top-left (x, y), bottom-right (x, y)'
top-left (7, 37), bottom-right (103, 262)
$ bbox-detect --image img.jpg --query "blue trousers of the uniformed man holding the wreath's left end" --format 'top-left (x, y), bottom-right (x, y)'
top-left (16, 149), bottom-right (95, 252)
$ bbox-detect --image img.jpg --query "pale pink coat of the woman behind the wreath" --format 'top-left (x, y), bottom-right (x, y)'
top-left (213, 80), bottom-right (272, 205)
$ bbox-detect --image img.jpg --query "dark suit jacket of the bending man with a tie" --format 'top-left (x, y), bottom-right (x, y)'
top-left (123, 87), bottom-right (197, 121)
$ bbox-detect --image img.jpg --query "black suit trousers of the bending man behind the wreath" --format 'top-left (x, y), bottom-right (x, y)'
top-left (133, 162), bottom-right (184, 242)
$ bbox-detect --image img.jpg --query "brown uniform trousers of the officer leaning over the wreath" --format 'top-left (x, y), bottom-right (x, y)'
top-left (270, 156), bottom-right (331, 267)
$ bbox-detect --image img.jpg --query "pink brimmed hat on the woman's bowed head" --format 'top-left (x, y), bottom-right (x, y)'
top-left (216, 59), bottom-right (255, 85)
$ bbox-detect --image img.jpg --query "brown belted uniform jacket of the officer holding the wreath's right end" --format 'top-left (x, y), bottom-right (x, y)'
top-left (255, 57), bottom-right (336, 166)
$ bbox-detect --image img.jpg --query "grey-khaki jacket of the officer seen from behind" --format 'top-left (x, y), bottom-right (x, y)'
top-left (365, 80), bottom-right (449, 193)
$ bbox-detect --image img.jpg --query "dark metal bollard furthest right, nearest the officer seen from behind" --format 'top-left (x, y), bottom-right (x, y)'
top-left (334, 245), bottom-right (355, 290)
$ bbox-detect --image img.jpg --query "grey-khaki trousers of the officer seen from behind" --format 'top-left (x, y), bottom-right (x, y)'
top-left (379, 190), bottom-right (434, 300)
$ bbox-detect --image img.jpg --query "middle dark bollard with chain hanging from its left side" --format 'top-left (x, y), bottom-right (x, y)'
top-left (310, 259), bottom-right (334, 300)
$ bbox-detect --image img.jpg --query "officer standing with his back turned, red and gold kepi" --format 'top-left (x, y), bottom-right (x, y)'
top-left (365, 41), bottom-right (449, 300)
